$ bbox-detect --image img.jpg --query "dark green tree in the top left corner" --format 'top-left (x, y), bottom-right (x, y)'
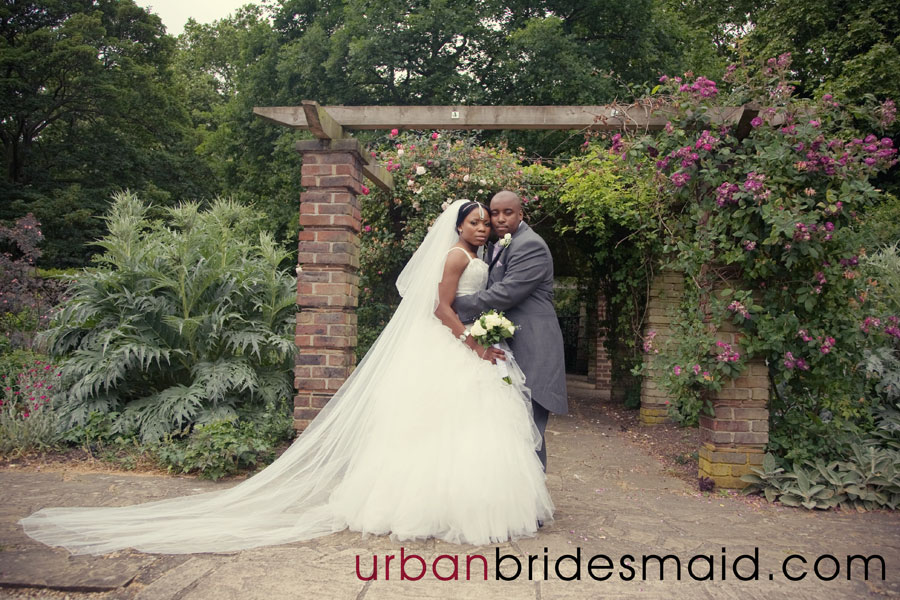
top-left (0, 0), bottom-right (220, 266)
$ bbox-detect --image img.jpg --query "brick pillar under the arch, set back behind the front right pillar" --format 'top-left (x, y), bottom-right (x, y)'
top-left (641, 271), bottom-right (684, 425)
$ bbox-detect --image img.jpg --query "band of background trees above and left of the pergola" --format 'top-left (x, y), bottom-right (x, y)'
top-left (0, 0), bottom-right (900, 266)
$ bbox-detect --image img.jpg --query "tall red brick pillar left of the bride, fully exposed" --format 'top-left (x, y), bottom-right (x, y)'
top-left (294, 139), bottom-right (362, 430)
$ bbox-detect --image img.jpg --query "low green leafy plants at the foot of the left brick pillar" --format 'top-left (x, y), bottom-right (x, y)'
top-left (155, 402), bottom-right (293, 480)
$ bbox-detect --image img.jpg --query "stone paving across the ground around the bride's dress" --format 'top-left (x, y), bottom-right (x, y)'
top-left (0, 379), bottom-right (900, 600)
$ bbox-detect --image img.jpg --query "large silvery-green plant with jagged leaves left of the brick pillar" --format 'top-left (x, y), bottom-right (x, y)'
top-left (46, 194), bottom-right (296, 442)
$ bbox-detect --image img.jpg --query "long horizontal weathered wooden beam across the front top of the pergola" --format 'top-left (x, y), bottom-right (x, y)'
top-left (253, 105), bottom-right (742, 131)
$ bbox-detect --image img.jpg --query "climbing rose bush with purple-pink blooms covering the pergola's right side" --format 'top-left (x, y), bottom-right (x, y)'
top-left (611, 55), bottom-right (900, 459)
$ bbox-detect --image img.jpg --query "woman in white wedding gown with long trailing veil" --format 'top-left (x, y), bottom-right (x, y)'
top-left (19, 200), bottom-right (553, 554)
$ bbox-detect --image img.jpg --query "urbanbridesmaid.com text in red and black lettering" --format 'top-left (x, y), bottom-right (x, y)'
top-left (356, 547), bottom-right (886, 581)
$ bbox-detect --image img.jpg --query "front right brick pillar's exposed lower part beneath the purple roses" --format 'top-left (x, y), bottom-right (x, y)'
top-left (699, 321), bottom-right (769, 488)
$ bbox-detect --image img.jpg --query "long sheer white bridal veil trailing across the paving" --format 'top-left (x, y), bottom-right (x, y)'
top-left (19, 200), bottom-right (478, 554)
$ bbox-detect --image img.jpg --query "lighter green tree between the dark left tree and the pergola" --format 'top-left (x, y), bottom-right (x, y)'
top-left (174, 5), bottom-right (298, 248)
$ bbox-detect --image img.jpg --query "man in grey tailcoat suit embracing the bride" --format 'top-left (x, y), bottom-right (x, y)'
top-left (453, 190), bottom-right (568, 471)
